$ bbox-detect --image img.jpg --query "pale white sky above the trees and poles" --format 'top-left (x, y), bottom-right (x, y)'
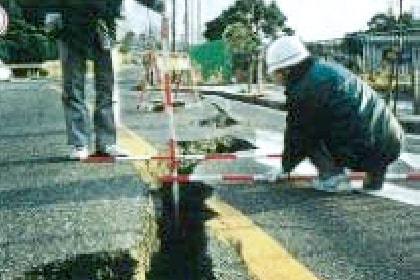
top-left (122, 0), bottom-right (420, 41)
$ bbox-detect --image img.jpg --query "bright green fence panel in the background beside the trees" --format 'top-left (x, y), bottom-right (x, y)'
top-left (189, 40), bottom-right (232, 82)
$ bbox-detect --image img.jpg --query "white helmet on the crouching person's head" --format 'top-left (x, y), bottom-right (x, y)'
top-left (266, 35), bottom-right (309, 74)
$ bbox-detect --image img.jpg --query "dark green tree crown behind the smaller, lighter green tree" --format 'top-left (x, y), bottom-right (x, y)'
top-left (204, 0), bottom-right (286, 41)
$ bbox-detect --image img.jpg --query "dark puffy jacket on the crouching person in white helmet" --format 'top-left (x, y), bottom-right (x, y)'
top-left (283, 58), bottom-right (403, 172)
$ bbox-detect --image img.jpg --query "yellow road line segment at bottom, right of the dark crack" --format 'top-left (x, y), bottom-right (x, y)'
top-left (207, 198), bottom-right (318, 280)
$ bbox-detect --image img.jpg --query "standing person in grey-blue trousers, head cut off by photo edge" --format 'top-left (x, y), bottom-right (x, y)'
top-left (46, 0), bottom-right (124, 159)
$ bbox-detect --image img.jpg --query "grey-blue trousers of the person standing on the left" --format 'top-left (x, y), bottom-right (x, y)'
top-left (59, 35), bottom-right (116, 149)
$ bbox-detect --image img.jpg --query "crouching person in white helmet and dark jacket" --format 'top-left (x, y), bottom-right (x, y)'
top-left (266, 36), bottom-right (403, 192)
